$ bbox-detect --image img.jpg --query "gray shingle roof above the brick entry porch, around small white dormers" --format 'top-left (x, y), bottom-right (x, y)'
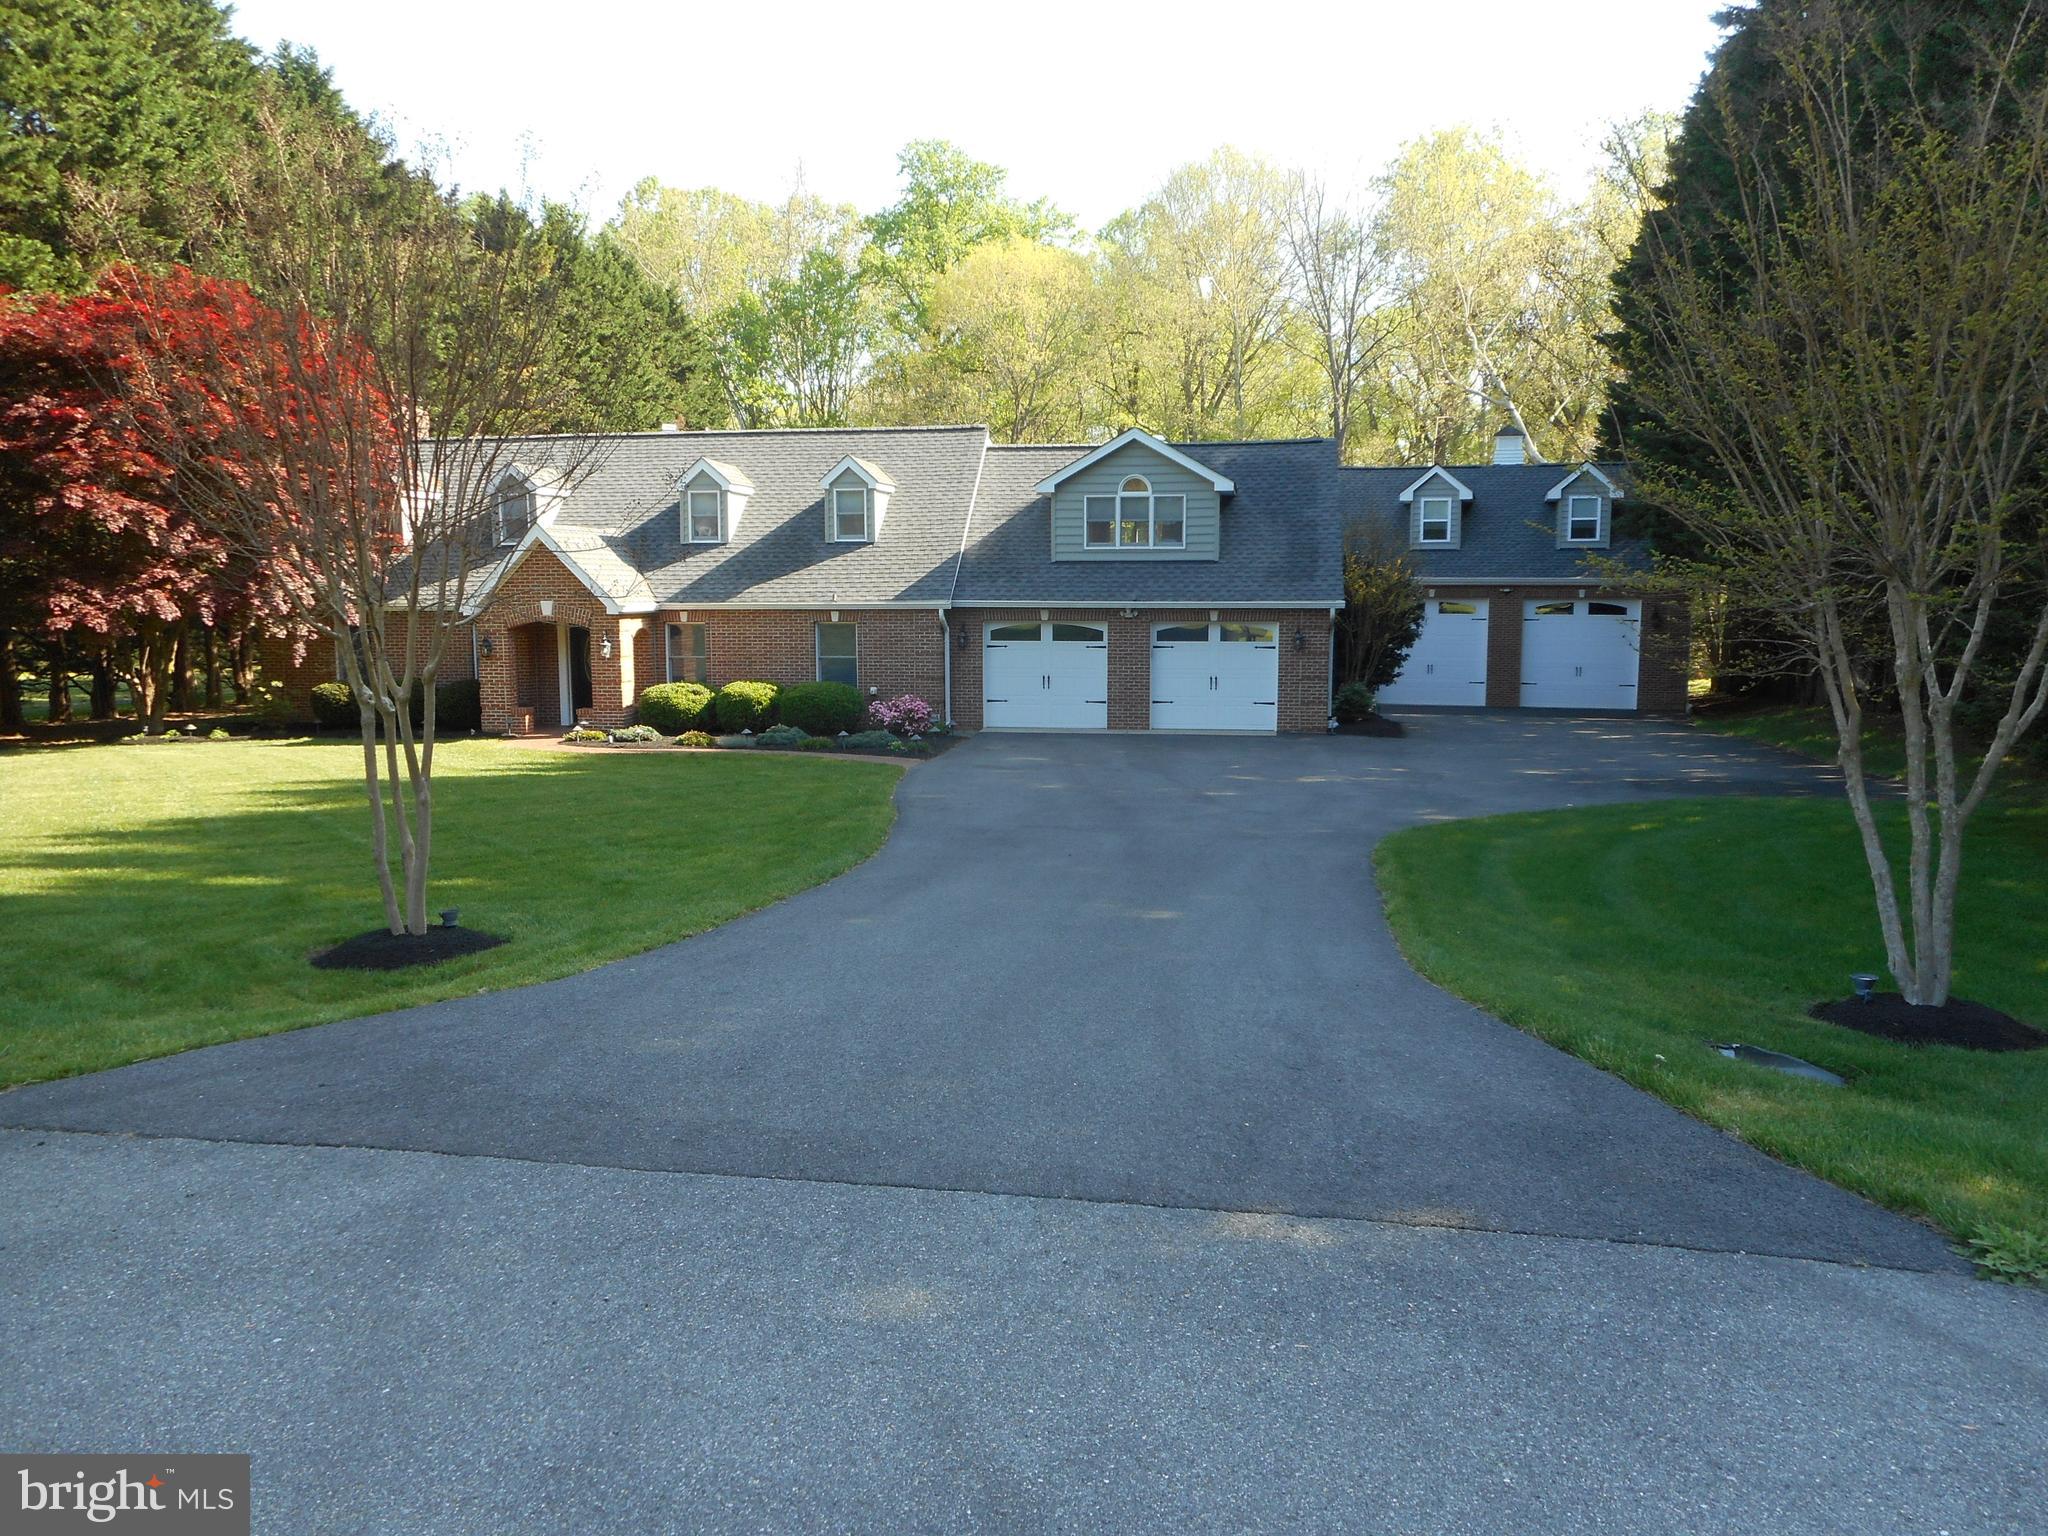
top-left (471, 426), bottom-right (987, 608)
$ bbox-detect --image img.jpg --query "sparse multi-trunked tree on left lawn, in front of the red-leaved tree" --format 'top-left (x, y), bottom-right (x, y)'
top-left (117, 111), bottom-right (598, 934)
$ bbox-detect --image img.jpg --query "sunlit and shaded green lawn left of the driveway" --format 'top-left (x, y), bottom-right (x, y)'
top-left (0, 741), bottom-right (901, 1085)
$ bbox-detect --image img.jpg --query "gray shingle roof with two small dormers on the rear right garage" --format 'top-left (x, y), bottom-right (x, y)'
top-left (1341, 463), bottom-right (1649, 582)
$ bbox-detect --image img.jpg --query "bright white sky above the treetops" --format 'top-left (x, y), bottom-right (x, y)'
top-left (220, 0), bottom-right (1726, 229)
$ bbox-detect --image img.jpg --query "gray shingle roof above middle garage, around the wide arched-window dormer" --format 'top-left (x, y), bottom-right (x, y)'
top-left (954, 438), bottom-right (1343, 606)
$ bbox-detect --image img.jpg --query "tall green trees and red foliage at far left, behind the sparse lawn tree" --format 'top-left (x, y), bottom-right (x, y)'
top-left (0, 0), bottom-right (727, 729)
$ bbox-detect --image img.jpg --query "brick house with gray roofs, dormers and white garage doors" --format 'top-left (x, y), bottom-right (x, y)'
top-left (272, 426), bottom-right (1686, 731)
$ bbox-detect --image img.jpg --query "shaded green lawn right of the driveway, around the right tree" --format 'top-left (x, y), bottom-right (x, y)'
top-left (1376, 799), bottom-right (2048, 1266)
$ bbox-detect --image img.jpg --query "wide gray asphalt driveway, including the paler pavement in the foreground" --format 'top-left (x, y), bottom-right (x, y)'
top-left (0, 715), bottom-right (2048, 1532)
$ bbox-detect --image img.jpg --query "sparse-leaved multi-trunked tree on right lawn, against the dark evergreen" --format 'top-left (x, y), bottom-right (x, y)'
top-left (1618, 2), bottom-right (2048, 1006)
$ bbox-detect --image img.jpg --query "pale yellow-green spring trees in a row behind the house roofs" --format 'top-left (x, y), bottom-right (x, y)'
top-left (608, 121), bottom-right (1665, 463)
